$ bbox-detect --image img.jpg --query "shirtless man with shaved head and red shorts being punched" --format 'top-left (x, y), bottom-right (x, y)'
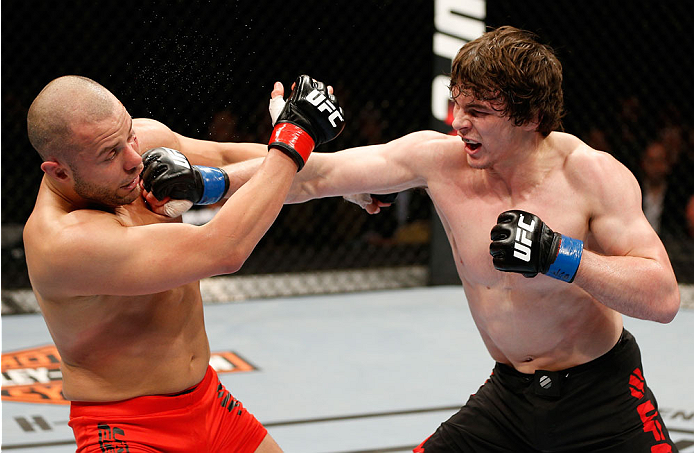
top-left (24, 72), bottom-right (344, 453)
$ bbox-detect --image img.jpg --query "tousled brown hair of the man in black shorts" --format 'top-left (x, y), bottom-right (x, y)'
top-left (449, 26), bottom-right (564, 136)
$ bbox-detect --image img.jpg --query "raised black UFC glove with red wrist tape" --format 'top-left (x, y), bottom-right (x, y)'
top-left (268, 75), bottom-right (345, 171)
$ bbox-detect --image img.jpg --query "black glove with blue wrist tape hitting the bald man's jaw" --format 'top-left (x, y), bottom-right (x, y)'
top-left (140, 147), bottom-right (229, 205)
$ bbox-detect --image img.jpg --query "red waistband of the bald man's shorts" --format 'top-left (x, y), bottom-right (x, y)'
top-left (70, 365), bottom-right (218, 418)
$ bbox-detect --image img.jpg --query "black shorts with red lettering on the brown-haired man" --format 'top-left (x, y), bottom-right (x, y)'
top-left (414, 330), bottom-right (677, 453)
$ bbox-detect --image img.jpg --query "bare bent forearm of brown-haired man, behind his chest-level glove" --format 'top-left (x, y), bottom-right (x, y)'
top-left (572, 250), bottom-right (680, 323)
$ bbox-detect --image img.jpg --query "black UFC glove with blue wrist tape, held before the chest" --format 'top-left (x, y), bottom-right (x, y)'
top-left (489, 210), bottom-right (583, 283)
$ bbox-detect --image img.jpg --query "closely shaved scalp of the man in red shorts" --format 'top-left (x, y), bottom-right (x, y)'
top-left (27, 76), bottom-right (118, 161)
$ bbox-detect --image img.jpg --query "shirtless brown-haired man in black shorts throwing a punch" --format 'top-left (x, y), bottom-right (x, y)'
top-left (144, 27), bottom-right (680, 453)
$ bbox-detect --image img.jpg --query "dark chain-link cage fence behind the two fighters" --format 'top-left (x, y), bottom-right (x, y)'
top-left (0, 0), bottom-right (694, 306)
